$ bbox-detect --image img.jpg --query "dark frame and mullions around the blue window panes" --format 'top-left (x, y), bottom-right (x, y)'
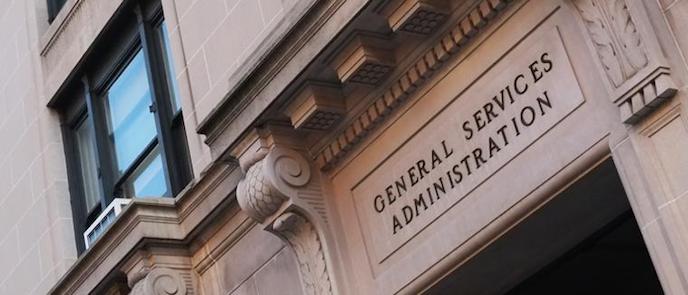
top-left (55, 0), bottom-right (192, 253)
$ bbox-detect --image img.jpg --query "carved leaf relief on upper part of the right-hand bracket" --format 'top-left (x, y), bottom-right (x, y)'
top-left (574, 0), bottom-right (648, 87)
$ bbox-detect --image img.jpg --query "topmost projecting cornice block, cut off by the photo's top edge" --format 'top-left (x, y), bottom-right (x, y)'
top-left (388, 0), bottom-right (447, 35)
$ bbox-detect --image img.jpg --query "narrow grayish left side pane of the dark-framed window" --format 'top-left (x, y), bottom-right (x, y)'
top-left (75, 118), bottom-right (100, 212)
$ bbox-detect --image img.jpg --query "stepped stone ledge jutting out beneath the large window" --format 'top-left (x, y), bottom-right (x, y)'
top-left (49, 163), bottom-right (241, 294)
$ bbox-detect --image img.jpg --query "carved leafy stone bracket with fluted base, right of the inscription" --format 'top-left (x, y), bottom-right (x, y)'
top-left (573, 0), bottom-right (677, 124)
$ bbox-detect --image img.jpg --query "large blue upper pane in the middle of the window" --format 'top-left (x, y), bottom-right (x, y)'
top-left (107, 50), bottom-right (157, 173)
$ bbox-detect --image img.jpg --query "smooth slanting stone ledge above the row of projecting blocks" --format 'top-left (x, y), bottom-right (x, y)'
top-left (197, 0), bottom-right (367, 158)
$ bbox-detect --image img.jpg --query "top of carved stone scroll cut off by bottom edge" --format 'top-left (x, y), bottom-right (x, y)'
top-left (129, 267), bottom-right (194, 295)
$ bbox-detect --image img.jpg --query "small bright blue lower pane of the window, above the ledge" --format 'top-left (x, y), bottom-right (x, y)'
top-left (127, 147), bottom-right (169, 198)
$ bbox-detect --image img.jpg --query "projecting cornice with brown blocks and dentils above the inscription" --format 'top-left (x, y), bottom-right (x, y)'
top-left (199, 0), bottom-right (494, 169)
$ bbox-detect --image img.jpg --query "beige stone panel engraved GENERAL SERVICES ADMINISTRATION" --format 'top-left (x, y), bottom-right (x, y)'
top-left (352, 27), bottom-right (584, 263)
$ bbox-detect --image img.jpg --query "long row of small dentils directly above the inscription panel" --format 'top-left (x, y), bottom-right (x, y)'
top-left (316, 0), bottom-right (510, 170)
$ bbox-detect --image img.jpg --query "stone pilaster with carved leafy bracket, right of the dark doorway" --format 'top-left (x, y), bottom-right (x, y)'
top-left (572, 0), bottom-right (688, 294)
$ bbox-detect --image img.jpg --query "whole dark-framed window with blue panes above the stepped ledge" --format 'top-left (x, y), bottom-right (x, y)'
top-left (58, 1), bottom-right (192, 252)
